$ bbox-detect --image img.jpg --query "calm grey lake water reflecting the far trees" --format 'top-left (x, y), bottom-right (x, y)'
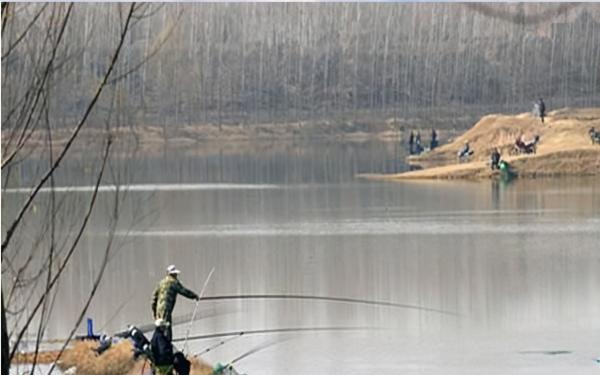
top-left (3, 142), bottom-right (600, 374)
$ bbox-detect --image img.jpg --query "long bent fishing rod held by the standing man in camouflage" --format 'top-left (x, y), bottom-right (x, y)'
top-left (202, 294), bottom-right (459, 316)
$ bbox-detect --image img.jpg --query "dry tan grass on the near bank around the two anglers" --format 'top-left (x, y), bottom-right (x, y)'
top-left (16, 340), bottom-right (212, 375)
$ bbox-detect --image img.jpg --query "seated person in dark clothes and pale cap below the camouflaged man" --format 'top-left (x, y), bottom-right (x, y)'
top-left (150, 318), bottom-right (190, 375)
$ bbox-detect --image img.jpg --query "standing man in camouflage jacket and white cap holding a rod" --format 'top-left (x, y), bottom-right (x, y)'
top-left (152, 265), bottom-right (200, 340)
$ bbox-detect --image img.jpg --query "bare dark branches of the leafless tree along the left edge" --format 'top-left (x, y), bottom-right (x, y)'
top-left (2, 3), bottom-right (155, 374)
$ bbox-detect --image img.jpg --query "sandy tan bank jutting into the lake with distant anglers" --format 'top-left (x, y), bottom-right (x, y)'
top-left (359, 108), bottom-right (600, 180)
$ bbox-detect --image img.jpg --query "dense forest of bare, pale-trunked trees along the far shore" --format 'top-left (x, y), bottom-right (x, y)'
top-left (2, 3), bottom-right (600, 132)
